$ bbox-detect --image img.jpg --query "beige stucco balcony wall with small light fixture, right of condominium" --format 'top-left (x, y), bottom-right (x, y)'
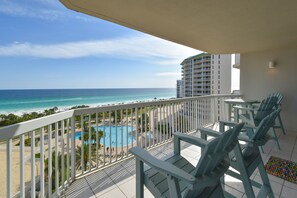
top-left (240, 47), bottom-right (297, 133)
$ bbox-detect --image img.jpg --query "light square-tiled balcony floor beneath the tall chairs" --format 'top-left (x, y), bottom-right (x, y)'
top-left (62, 127), bottom-right (297, 198)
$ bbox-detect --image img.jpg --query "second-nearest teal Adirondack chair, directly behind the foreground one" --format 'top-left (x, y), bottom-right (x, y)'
top-left (200, 109), bottom-right (280, 198)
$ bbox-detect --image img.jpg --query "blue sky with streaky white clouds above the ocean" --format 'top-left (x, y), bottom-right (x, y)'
top-left (0, 0), bottom-right (238, 89)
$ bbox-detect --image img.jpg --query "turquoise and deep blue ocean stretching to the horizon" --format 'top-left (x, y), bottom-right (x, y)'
top-left (0, 88), bottom-right (176, 114)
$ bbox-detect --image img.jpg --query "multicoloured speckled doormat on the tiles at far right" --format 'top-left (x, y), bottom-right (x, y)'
top-left (265, 156), bottom-right (297, 184)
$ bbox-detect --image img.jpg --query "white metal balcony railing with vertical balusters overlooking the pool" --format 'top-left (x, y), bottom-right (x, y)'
top-left (0, 95), bottom-right (240, 197)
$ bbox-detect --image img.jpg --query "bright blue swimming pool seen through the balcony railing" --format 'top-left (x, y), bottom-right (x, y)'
top-left (75, 125), bottom-right (135, 148)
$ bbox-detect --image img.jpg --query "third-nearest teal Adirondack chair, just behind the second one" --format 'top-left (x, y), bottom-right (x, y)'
top-left (233, 94), bottom-right (280, 151)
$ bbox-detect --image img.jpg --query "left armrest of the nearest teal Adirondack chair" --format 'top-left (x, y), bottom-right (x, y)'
top-left (129, 146), bottom-right (196, 184)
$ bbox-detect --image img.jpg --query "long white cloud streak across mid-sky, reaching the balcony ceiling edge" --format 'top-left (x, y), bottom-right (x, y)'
top-left (0, 35), bottom-right (200, 64)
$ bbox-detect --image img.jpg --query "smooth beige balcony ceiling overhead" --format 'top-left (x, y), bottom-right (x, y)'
top-left (61, 0), bottom-right (297, 53)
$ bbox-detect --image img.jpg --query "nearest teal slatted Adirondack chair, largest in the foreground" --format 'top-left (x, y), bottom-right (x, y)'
top-left (130, 123), bottom-right (244, 198)
